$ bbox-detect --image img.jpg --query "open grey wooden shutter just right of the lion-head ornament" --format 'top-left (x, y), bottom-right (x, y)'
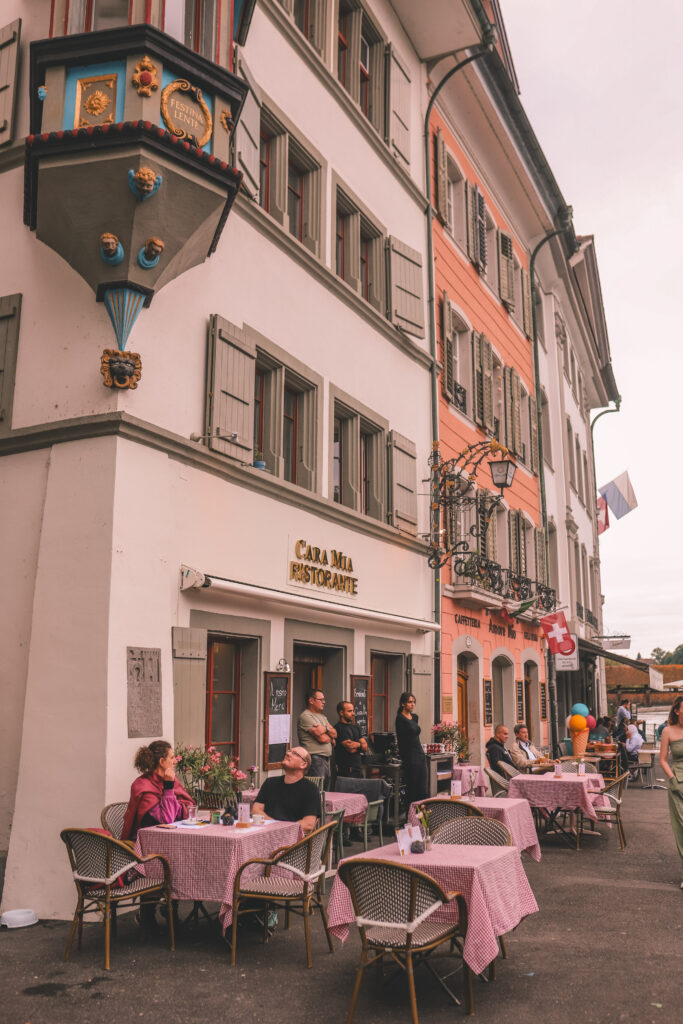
top-left (206, 315), bottom-right (256, 456)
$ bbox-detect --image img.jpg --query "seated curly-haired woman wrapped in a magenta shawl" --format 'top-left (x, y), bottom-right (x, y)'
top-left (121, 739), bottom-right (195, 840)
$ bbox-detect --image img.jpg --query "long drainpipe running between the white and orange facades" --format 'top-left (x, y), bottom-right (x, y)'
top-left (424, 26), bottom-right (495, 722)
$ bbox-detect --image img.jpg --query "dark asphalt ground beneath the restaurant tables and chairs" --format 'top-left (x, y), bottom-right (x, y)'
top-left (0, 786), bottom-right (683, 1024)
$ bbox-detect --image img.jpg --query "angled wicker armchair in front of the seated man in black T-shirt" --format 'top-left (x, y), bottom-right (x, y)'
top-left (230, 821), bottom-right (338, 967)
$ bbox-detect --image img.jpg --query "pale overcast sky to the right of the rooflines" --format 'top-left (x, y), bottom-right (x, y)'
top-left (502, 0), bottom-right (683, 656)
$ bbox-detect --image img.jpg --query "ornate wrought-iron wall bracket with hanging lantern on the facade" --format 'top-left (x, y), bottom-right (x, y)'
top-left (428, 439), bottom-right (517, 568)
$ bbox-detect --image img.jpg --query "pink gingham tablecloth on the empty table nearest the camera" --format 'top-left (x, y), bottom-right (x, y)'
top-left (328, 843), bottom-right (539, 974)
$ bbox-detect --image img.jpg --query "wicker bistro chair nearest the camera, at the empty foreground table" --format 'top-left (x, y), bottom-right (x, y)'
top-left (339, 857), bottom-right (474, 1024)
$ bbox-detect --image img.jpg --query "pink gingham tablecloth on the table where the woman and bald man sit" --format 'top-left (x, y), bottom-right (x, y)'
top-left (135, 821), bottom-right (303, 931)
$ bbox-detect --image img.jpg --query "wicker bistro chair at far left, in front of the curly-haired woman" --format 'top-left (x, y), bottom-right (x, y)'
top-left (60, 812), bottom-right (175, 971)
